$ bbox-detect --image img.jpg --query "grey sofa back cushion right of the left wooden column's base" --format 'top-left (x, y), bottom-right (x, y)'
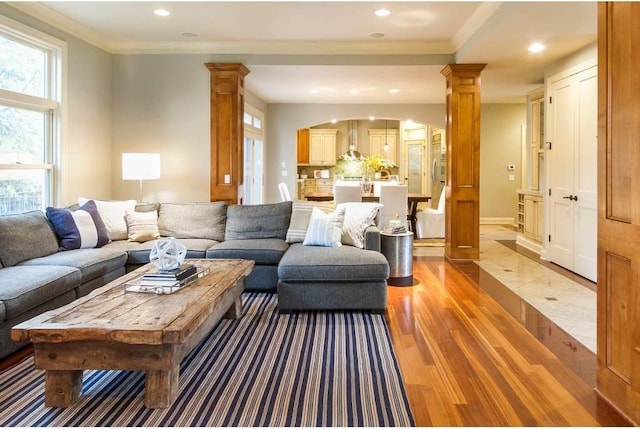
top-left (224, 201), bottom-right (292, 240)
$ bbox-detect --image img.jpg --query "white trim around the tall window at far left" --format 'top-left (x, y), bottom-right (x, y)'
top-left (0, 15), bottom-right (69, 206)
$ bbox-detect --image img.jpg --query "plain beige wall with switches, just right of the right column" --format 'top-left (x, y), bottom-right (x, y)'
top-left (480, 103), bottom-right (527, 220)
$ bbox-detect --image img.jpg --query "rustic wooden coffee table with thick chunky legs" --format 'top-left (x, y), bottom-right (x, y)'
top-left (11, 259), bottom-right (254, 408)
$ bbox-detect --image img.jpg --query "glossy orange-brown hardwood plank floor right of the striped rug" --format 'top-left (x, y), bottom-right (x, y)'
top-left (387, 257), bottom-right (627, 426)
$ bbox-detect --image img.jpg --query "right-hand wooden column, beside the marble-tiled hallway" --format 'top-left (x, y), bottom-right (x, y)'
top-left (441, 64), bottom-right (486, 259)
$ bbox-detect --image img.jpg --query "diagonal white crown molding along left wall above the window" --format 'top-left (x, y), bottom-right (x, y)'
top-left (9, 1), bottom-right (114, 53)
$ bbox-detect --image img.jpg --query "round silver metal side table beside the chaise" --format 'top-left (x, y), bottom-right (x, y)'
top-left (380, 232), bottom-right (413, 286)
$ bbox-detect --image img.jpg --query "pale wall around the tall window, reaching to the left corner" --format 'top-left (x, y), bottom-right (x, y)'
top-left (0, 3), bottom-right (112, 206)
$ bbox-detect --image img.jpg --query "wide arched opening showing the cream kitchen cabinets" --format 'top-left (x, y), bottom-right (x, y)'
top-left (297, 117), bottom-right (446, 206)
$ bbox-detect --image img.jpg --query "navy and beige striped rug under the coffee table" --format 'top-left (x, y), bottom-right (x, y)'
top-left (0, 293), bottom-right (415, 426)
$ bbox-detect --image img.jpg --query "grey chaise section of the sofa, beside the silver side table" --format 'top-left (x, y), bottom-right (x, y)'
top-left (278, 243), bottom-right (389, 313)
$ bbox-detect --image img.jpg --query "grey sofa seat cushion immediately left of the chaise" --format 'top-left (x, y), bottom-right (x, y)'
top-left (206, 238), bottom-right (289, 265)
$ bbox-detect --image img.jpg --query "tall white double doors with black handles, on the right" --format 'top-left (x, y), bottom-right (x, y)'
top-left (547, 67), bottom-right (598, 281)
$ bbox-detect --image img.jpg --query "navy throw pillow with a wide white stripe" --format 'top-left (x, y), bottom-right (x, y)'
top-left (47, 200), bottom-right (109, 250)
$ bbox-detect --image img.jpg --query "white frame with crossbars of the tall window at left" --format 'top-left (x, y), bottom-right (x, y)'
top-left (0, 15), bottom-right (68, 210)
